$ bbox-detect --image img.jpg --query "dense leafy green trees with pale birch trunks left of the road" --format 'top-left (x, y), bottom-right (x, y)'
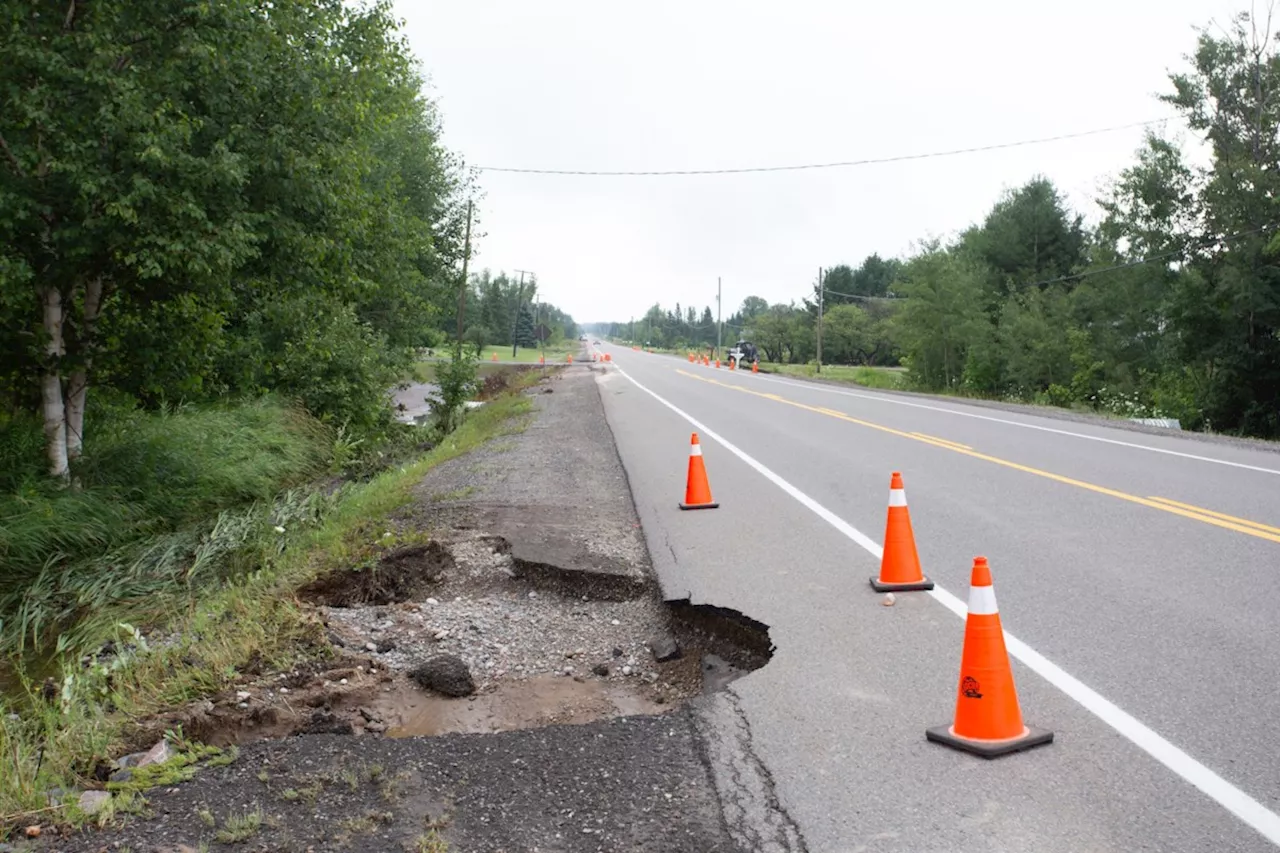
top-left (0, 0), bottom-right (572, 478)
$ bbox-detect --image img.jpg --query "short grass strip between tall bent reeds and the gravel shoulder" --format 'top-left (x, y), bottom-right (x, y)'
top-left (0, 371), bottom-right (539, 839)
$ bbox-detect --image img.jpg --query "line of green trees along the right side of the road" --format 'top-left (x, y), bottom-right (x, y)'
top-left (593, 14), bottom-right (1280, 437)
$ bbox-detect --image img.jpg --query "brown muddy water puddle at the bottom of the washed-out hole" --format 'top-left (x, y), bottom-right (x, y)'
top-left (375, 675), bottom-right (671, 738)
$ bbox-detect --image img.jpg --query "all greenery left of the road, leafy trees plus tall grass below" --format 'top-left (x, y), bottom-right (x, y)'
top-left (0, 0), bottom-right (576, 650)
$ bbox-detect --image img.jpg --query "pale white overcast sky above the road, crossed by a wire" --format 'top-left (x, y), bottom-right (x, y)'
top-left (397, 0), bottom-right (1248, 323)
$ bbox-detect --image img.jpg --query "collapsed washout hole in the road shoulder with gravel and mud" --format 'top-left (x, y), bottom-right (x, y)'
top-left (132, 529), bottom-right (773, 745)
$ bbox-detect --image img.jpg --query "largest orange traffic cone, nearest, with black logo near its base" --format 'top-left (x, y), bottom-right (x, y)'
top-left (924, 557), bottom-right (1053, 758)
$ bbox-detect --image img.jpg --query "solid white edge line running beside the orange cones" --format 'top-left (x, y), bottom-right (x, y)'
top-left (618, 368), bottom-right (1280, 847)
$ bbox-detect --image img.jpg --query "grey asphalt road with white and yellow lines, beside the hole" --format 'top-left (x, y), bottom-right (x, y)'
top-left (588, 346), bottom-right (1280, 853)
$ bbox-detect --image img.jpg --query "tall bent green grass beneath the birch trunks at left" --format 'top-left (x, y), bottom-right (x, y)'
top-left (0, 398), bottom-right (333, 654)
